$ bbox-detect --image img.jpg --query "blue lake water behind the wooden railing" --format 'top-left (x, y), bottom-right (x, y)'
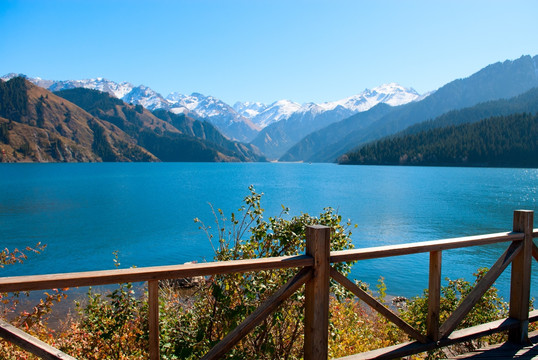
top-left (0, 163), bottom-right (538, 297)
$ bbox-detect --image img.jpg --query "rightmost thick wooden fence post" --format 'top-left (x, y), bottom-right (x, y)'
top-left (508, 210), bottom-right (534, 344)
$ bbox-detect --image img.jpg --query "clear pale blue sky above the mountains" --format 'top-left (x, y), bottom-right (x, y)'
top-left (0, 0), bottom-right (538, 104)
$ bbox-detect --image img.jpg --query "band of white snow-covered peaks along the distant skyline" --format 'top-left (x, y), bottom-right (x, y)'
top-left (2, 74), bottom-right (421, 138)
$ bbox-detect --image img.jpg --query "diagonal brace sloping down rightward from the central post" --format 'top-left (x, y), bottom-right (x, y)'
top-left (331, 267), bottom-right (430, 343)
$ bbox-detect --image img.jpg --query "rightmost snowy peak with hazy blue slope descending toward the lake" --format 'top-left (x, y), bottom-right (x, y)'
top-left (247, 83), bottom-right (420, 159)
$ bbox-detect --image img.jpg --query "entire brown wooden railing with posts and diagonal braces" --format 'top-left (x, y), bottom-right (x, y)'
top-left (0, 210), bottom-right (538, 360)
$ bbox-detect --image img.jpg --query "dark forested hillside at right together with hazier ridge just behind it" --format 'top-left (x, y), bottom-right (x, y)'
top-left (338, 77), bottom-right (538, 167)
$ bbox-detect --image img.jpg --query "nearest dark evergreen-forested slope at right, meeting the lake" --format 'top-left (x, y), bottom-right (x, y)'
top-left (339, 113), bottom-right (538, 167)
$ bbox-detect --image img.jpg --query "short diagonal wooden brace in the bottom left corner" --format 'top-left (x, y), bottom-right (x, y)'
top-left (0, 320), bottom-right (76, 360)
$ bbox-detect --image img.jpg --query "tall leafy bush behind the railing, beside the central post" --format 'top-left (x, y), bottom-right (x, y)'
top-left (163, 187), bottom-right (352, 359)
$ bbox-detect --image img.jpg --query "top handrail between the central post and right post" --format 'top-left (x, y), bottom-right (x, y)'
top-left (331, 232), bottom-right (524, 263)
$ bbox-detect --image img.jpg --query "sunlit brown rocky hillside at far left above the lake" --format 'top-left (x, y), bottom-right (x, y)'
top-left (0, 77), bottom-right (153, 162)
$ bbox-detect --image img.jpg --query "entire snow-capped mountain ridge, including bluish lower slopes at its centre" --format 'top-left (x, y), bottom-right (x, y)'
top-left (2, 73), bottom-right (418, 146)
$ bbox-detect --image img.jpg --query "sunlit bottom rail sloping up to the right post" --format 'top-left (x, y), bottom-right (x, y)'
top-left (336, 319), bottom-right (519, 360)
